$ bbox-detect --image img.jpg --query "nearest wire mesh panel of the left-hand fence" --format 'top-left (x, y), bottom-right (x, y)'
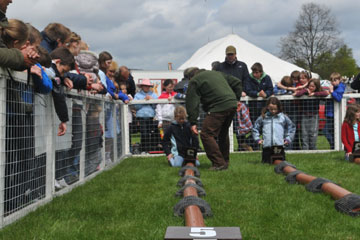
top-left (4, 79), bottom-right (46, 216)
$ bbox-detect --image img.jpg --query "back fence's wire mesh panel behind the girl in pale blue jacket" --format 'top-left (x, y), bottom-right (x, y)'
top-left (233, 95), bottom-right (335, 151)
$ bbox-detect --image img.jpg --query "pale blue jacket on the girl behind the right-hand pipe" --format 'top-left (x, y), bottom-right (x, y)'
top-left (252, 112), bottom-right (296, 147)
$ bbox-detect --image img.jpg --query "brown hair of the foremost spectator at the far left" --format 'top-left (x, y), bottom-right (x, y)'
top-left (1, 19), bottom-right (30, 48)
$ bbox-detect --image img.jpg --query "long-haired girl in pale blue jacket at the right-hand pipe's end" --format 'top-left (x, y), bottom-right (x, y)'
top-left (252, 97), bottom-right (296, 163)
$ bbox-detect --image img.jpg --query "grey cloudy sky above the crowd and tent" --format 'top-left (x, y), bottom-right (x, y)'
top-left (7, 0), bottom-right (360, 70)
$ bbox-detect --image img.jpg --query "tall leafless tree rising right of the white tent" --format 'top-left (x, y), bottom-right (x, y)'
top-left (280, 3), bottom-right (342, 72)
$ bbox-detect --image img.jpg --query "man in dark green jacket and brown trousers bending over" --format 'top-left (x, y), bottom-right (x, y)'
top-left (186, 68), bottom-right (242, 170)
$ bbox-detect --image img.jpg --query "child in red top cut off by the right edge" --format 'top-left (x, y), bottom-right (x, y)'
top-left (341, 104), bottom-right (360, 161)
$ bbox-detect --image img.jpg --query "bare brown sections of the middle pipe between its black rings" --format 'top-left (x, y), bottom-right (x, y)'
top-left (184, 163), bottom-right (205, 227)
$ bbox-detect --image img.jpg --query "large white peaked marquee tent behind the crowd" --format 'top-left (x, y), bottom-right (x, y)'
top-left (178, 34), bottom-right (318, 82)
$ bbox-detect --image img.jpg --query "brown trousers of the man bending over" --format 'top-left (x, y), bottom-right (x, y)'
top-left (200, 108), bottom-right (236, 167)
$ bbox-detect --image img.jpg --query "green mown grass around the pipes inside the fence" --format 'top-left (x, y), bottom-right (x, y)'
top-left (0, 152), bottom-right (360, 240)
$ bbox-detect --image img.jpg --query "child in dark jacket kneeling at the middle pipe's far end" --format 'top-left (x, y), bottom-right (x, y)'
top-left (163, 106), bottom-right (200, 167)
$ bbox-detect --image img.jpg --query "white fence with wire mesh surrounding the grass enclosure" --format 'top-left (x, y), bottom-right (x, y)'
top-left (0, 69), bottom-right (360, 227)
